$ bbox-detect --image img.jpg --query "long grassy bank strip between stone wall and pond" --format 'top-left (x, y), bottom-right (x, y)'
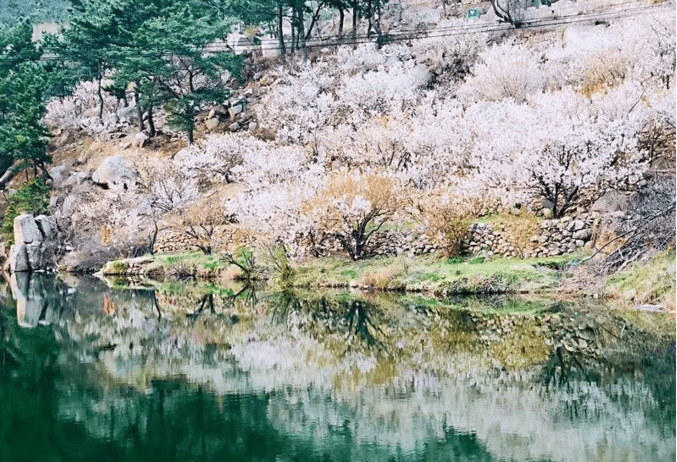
top-left (104, 252), bottom-right (581, 296)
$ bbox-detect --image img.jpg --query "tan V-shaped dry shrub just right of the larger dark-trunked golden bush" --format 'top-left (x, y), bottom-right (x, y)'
top-left (417, 189), bottom-right (482, 258)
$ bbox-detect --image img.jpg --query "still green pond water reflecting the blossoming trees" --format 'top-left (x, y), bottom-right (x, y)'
top-left (0, 278), bottom-right (675, 462)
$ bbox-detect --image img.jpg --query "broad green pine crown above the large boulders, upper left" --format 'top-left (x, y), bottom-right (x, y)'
top-left (59, 0), bottom-right (242, 142)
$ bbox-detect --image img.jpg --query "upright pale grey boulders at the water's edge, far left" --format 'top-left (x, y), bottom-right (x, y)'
top-left (9, 213), bottom-right (57, 273)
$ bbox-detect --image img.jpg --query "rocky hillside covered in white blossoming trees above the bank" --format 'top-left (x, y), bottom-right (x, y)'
top-left (1, 0), bottom-right (675, 308)
